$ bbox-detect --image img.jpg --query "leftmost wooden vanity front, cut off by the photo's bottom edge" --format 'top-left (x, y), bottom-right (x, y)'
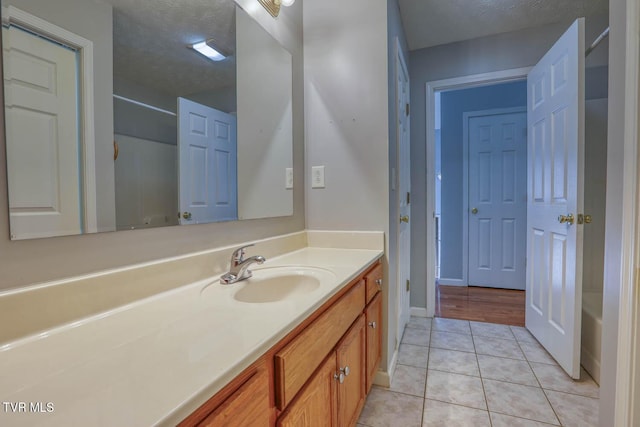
top-left (198, 367), bottom-right (271, 427)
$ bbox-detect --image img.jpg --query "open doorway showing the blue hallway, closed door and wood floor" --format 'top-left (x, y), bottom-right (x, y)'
top-left (435, 79), bottom-right (527, 326)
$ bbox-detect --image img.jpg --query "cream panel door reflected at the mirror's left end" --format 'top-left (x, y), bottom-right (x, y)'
top-left (2, 26), bottom-right (82, 239)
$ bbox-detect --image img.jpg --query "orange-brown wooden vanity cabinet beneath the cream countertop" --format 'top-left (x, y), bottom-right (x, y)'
top-left (180, 262), bottom-right (383, 427)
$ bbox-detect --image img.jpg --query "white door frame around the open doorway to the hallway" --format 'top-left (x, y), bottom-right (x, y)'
top-left (425, 67), bottom-right (532, 317)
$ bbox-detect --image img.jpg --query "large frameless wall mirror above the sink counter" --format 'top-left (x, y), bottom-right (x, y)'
top-left (2, 0), bottom-right (293, 239)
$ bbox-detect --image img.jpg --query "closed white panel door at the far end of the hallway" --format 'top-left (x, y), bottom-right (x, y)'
top-left (466, 111), bottom-right (527, 290)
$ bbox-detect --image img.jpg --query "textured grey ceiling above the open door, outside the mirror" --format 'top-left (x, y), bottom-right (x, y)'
top-left (399, 0), bottom-right (609, 50)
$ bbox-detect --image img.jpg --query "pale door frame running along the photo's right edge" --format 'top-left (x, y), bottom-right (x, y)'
top-left (600, 0), bottom-right (640, 426)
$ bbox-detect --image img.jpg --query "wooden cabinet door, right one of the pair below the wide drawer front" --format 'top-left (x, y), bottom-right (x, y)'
top-left (336, 315), bottom-right (366, 426)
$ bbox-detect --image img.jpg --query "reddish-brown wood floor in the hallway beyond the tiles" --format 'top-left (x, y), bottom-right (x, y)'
top-left (436, 285), bottom-right (525, 326)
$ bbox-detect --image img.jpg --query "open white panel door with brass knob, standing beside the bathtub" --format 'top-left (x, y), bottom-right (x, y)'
top-left (526, 19), bottom-right (584, 378)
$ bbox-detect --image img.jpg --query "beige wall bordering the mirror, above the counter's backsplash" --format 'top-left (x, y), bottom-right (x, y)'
top-left (0, 0), bottom-right (304, 289)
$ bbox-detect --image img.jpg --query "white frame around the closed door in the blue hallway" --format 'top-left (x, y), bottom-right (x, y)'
top-left (462, 105), bottom-right (527, 286)
